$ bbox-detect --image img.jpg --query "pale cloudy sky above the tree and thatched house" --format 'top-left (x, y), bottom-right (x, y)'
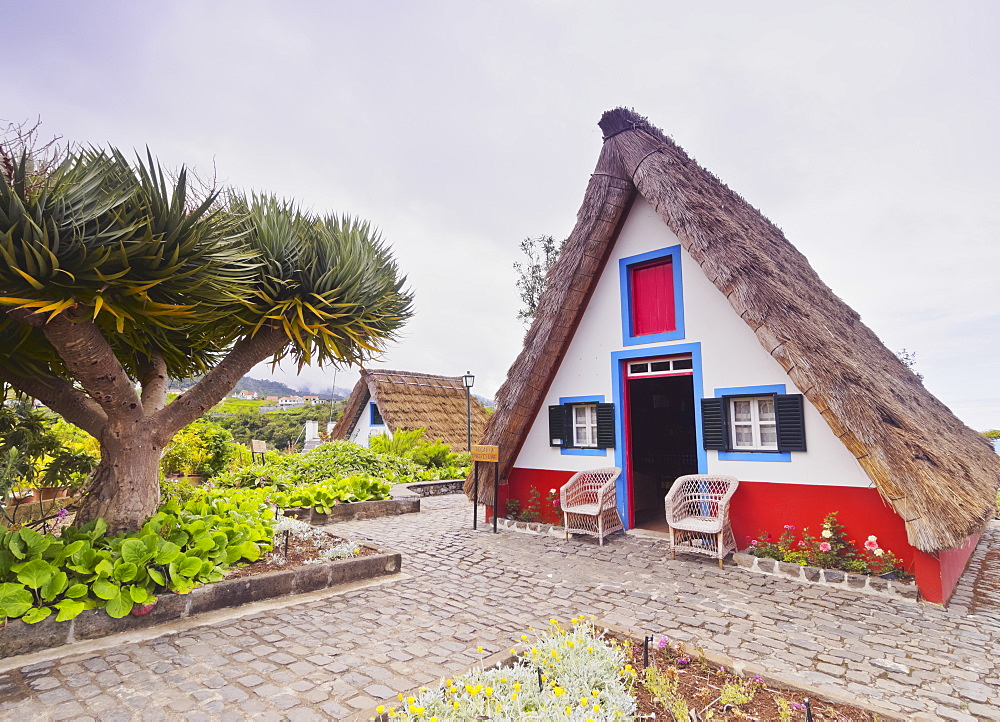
top-left (7, 0), bottom-right (1000, 429)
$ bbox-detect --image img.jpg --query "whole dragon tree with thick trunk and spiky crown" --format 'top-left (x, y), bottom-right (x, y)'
top-left (0, 143), bottom-right (412, 531)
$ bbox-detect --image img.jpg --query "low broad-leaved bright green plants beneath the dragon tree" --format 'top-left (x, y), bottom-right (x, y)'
top-left (0, 490), bottom-right (274, 623)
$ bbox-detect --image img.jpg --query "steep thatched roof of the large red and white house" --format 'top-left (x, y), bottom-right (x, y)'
top-left (472, 108), bottom-right (1000, 552)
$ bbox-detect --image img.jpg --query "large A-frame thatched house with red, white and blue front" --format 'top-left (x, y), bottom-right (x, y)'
top-left (470, 109), bottom-right (1000, 601)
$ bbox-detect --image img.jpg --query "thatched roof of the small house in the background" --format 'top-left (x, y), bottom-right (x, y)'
top-left (333, 369), bottom-right (489, 452)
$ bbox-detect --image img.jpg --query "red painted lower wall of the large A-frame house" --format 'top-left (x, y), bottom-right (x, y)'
top-left (500, 468), bottom-right (979, 603)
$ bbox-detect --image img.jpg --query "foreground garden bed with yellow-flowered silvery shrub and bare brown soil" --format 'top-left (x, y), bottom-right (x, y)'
top-left (372, 618), bottom-right (902, 722)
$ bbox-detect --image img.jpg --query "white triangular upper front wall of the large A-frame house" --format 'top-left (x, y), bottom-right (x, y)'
top-left (514, 197), bottom-right (872, 487)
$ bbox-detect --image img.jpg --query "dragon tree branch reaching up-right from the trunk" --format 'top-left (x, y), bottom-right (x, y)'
top-left (152, 326), bottom-right (289, 436)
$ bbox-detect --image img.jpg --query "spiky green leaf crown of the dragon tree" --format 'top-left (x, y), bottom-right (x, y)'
top-left (0, 149), bottom-right (411, 378)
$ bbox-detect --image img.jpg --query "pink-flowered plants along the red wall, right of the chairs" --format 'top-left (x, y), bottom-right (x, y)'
top-left (747, 511), bottom-right (903, 574)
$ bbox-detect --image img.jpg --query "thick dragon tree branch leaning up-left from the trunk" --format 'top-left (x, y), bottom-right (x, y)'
top-left (8, 308), bottom-right (142, 418)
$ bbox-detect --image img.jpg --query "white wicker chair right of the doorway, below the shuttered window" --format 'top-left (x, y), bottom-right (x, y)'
top-left (664, 474), bottom-right (740, 569)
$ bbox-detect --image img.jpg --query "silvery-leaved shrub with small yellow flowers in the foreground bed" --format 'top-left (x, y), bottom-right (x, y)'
top-left (376, 619), bottom-right (636, 722)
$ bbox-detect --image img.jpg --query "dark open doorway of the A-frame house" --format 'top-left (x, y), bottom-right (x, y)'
top-left (628, 375), bottom-right (698, 526)
